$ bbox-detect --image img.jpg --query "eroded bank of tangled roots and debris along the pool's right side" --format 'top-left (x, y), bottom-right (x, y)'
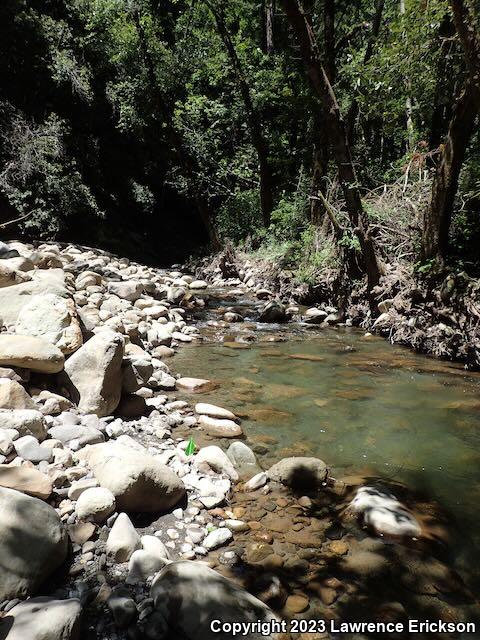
top-left (190, 248), bottom-right (480, 371)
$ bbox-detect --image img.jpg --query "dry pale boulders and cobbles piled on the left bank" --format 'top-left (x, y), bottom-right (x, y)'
top-left (0, 243), bottom-right (282, 640)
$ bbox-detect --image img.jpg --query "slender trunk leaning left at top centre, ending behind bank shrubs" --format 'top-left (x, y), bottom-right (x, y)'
top-left (206, 0), bottom-right (273, 227)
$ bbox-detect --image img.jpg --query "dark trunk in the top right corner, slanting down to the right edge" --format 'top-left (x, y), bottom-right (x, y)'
top-left (450, 0), bottom-right (480, 111)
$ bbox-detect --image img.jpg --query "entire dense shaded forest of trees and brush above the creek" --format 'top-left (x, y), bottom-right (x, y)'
top-left (0, 0), bottom-right (480, 286)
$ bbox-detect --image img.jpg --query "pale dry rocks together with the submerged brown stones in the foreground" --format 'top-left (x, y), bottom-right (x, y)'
top-left (0, 243), bottom-right (478, 640)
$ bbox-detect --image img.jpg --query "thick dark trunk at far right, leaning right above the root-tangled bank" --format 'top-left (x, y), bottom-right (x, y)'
top-left (422, 81), bottom-right (478, 266)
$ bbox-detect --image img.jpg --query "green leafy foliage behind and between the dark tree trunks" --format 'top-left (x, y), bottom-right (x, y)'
top-left (0, 0), bottom-right (480, 272)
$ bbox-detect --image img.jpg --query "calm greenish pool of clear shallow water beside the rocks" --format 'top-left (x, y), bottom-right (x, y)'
top-left (175, 329), bottom-right (480, 566)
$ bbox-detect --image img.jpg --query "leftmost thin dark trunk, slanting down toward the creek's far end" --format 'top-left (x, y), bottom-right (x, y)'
top-left (133, 9), bottom-right (222, 250)
